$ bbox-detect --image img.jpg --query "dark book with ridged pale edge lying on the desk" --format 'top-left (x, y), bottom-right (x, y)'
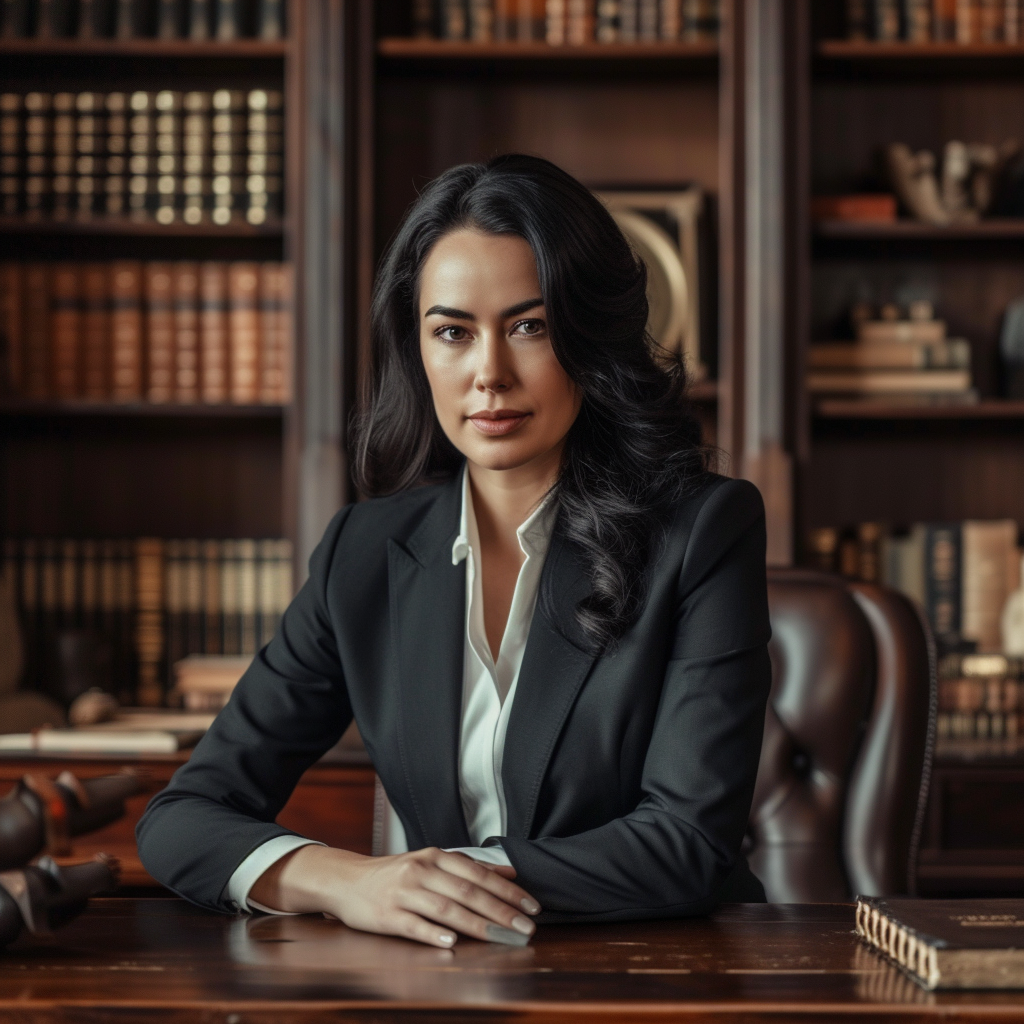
top-left (857, 896), bottom-right (1024, 989)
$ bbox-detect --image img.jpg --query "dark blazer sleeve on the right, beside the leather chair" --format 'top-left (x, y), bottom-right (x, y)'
top-left (488, 480), bottom-right (771, 921)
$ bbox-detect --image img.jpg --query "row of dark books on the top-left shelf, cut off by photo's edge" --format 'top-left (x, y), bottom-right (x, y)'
top-left (0, 0), bottom-right (285, 41)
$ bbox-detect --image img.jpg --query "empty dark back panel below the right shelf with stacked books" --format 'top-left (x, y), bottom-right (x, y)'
top-left (803, 421), bottom-right (1024, 526)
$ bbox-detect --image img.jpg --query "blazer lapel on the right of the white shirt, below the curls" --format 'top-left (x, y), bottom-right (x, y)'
top-left (502, 529), bottom-right (597, 839)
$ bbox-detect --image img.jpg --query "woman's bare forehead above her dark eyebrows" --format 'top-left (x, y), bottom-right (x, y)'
top-left (420, 228), bottom-right (541, 312)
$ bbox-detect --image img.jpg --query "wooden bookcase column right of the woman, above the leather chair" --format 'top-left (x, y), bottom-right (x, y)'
top-left (719, 0), bottom-right (793, 565)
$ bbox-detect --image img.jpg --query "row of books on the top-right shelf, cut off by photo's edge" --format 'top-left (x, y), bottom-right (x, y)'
top-left (846, 0), bottom-right (1024, 45)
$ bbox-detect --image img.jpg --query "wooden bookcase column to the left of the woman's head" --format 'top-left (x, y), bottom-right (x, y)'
top-left (286, 0), bottom-right (372, 582)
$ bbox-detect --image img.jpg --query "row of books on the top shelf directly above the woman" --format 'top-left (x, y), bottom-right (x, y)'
top-left (413, 0), bottom-right (721, 46)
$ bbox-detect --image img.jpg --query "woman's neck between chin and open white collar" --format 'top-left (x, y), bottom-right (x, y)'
top-left (467, 445), bottom-right (562, 550)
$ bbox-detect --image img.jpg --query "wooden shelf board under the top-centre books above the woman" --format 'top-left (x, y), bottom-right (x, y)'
top-left (377, 37), bottom-right (719, 62)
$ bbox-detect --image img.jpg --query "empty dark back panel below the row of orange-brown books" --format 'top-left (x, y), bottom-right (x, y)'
top-left (0, 417), bottom-right (282, 538)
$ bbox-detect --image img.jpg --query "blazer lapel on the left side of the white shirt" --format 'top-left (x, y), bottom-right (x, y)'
top-left (388, 476), bottom-right (471, 847)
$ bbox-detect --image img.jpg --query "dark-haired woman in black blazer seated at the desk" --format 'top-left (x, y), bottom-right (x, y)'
top-left (138, 156), bottom-right (770, 947)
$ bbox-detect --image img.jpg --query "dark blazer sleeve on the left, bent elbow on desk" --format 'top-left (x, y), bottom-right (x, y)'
top-left (135, 509), bottom-right (352, 912)
